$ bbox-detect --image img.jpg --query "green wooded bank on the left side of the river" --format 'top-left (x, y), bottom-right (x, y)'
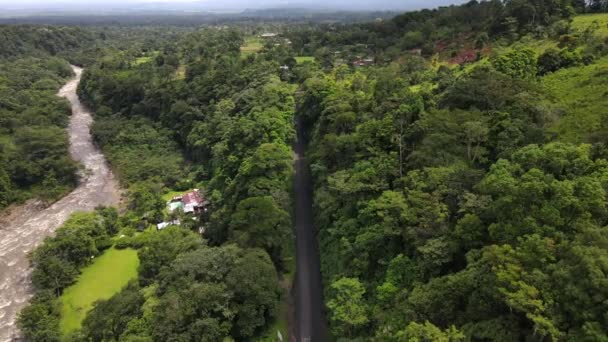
top-left (0, 56), bottom-right (78, 209)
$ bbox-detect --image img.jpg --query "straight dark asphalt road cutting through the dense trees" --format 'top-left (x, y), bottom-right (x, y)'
top-left (294, 118), bottom-right (328, 342)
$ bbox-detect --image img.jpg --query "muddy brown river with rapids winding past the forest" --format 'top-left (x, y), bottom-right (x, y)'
top-left (0, 67), bottom-right (120, 342)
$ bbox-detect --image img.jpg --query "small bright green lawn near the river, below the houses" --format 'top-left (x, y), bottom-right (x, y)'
top-left (59, 248), bottom-right (139, 335)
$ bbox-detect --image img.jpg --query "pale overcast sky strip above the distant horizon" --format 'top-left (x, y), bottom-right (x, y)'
top-left (0, 0), bottom-right (464, 11)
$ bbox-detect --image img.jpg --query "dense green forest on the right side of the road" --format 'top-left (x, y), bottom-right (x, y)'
top-left (297, 20), bottom-right (607, 341)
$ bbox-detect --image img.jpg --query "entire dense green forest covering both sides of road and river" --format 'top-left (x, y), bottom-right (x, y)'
top-left (7, 0), bottom-right (608, 341)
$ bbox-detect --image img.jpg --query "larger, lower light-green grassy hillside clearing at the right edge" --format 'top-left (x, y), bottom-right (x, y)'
top-left (542, 57), bottom-right (608, 143)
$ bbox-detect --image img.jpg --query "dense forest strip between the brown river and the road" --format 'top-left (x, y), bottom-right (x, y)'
top-left (20, 25), bottom-right (295, 341)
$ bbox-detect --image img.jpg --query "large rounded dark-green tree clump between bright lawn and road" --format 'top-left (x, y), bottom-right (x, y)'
top-left (152, 246), bottom-right (279, 341)
